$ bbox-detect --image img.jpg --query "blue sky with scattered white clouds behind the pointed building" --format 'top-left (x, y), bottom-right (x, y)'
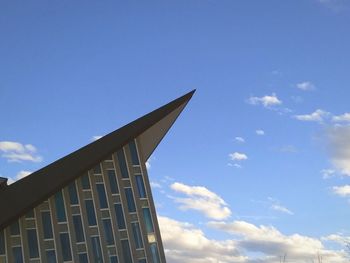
top-left (0, 0), bottom-right (350, 263)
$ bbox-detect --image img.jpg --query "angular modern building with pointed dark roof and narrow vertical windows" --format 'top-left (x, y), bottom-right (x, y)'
top-left (0, 91), bottom-right (194, 263)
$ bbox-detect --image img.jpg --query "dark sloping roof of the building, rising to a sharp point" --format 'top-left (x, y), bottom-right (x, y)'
top-left (0, 90), bottom-right (195, 230)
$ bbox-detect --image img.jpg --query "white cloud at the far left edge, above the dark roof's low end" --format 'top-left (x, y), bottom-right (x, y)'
top-left (0, 141), bottom-right (42, 162)
